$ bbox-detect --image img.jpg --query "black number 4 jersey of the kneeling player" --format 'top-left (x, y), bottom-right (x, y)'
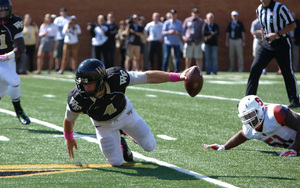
top-left (68, 67), bottom-right (130, 121)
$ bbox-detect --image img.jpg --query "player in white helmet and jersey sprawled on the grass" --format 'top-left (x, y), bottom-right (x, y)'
top-left (204, 95), bottom-right (300, 157)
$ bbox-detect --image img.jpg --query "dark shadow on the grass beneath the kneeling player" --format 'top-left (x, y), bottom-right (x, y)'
top-left (85, 161), bottom-right (199, 180)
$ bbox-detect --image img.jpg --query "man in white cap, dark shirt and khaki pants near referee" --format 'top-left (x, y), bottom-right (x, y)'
top-left (225, 10), bottom-right (246, 72)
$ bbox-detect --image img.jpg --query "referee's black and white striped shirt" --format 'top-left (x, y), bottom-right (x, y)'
top-left (256, 1), bottom-right (294, 37)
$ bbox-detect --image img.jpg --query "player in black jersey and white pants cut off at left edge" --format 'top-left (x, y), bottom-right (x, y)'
top-left (0, 0), bottom-right (30, 125)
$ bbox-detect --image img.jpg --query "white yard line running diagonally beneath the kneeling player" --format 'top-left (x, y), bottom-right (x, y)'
top-left (0, 108), bottom-right (236, 188)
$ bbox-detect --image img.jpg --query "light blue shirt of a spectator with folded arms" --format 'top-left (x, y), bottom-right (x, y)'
top-left (163, 19), bottom-right (183, 45)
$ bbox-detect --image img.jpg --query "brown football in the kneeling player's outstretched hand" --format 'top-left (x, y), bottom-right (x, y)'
top-left (184, 66), bottom-right (203, 97)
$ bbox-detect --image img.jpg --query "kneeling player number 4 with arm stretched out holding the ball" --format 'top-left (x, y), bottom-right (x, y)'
top-left (63, 59), bottom-right (191, 166)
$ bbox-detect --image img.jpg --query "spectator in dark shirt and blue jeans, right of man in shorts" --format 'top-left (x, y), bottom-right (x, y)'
top-left (203, 13), bottom-right (220, 75)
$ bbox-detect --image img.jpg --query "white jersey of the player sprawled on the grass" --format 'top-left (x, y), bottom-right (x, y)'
top-left (243, 105), bottom-right (297, 148)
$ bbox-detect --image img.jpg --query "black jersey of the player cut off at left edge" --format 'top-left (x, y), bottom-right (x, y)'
top-left (0, 15), bottom-right (24, 54)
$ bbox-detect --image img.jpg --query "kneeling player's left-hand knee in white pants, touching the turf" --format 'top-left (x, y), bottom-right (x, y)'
top-left (100, 137), bottom-right (124, 166)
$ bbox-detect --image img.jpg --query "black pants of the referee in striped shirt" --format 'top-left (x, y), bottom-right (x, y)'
top-left (246, 38), bottom-right (299, 104)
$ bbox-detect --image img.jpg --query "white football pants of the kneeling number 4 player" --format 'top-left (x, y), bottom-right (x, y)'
top-left (91, 98), bottom-right (156, 166)
